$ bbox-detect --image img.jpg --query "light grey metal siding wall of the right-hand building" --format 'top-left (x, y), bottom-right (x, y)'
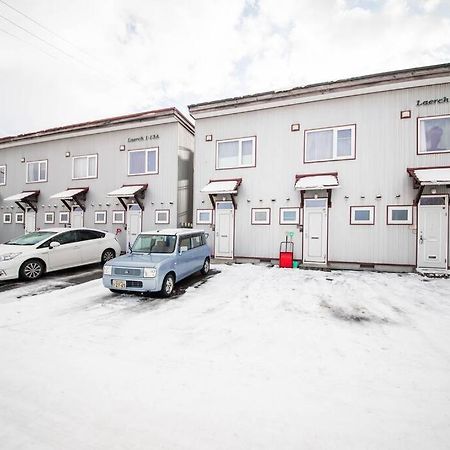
top-left (194, 84), bottom-right (450, 265)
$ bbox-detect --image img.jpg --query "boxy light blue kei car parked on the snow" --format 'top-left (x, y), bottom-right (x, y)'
top-left (103, 228), bottom-right (210, 297)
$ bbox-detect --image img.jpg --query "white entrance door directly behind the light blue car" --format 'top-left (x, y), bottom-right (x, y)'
top-left (214, 201), bottom-right (234, 258)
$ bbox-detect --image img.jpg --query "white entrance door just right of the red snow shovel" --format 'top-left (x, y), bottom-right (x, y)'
top-left (303, 198), bottom-right (328, 264)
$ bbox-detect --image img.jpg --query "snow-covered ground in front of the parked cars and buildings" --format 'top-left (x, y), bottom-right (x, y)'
top-left (0, 265), bottom-right (450, 450)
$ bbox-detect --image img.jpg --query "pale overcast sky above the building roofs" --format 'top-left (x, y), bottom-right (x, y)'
top-left (0, 0), bottom-right (450, 136)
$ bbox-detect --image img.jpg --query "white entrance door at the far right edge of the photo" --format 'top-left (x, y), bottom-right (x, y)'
top-left (417, 195), bottom-right (448, 269)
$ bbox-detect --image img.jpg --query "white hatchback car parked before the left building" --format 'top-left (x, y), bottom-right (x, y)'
top-left (0, 228), bottom-right (120, 281)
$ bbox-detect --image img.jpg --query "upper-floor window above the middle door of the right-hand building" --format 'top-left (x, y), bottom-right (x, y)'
top-left (305, 125), bottom-right (356, 162)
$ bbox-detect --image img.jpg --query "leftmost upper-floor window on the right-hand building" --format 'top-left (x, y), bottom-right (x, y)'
top-left (216, 136), bottom-right (256, 169)
